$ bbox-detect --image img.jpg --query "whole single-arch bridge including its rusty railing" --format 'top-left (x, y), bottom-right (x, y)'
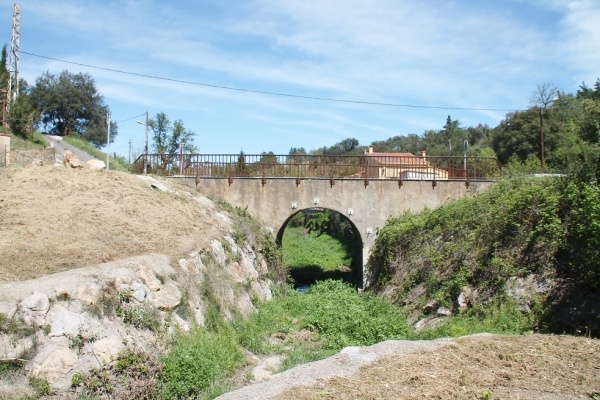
top-left (134, 153), bottom-right (501, 285)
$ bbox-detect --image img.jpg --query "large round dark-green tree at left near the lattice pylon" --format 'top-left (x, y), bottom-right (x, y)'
top-left (31, 71), bottom-right (116, 148)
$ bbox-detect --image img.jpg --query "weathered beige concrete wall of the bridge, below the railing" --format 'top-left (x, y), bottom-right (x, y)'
top-left (187, 178), bottom-right (493, 281)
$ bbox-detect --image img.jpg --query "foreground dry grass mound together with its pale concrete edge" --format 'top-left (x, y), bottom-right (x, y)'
top-left (219, 334), bottom-right (600, 400)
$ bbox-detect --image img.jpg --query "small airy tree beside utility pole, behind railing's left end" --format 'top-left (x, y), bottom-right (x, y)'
top-left (148, 112), bottom-right (197, 168)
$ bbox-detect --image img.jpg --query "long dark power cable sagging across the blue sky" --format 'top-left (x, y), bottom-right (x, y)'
top-left (21, 50), bottom-right (517, 112)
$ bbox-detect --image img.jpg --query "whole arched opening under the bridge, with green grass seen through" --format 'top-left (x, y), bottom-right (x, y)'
top-left (277, 208), bottom-right (363, 289)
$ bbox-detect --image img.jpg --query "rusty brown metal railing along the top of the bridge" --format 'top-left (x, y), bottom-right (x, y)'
top-left (133, 153), bottom-right (502, 181)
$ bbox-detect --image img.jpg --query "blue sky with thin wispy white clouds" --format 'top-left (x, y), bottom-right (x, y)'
top-left (0, 0), bottom-right (600, 155)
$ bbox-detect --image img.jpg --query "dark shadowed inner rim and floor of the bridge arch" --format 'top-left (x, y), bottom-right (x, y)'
top-left (276, 207), bottom-right (364, 288)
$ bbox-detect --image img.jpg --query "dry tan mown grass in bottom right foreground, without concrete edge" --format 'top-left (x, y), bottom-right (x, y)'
top-left (279, 335), bottom-right (600, 400)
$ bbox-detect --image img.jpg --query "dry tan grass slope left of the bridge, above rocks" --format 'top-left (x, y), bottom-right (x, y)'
top-left (0, 167), bottom-right (226, 282)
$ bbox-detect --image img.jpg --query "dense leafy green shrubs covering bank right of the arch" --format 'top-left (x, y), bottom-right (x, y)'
top-left (370, 166), bottom-right (600, 332)
